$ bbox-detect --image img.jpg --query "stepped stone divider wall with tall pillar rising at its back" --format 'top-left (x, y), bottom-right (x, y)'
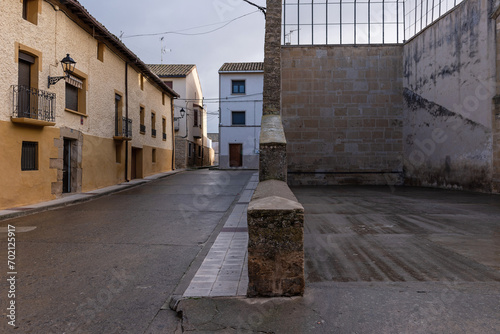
top-left (247, 0), bottom-right (305, 297)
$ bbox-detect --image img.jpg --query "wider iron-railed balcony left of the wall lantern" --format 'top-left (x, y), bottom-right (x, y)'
top-left (11, 86), bottom-right (56, 126)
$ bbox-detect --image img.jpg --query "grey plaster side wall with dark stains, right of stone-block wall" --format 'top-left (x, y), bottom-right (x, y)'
top-left (404, 0), bottom-right (496, 191)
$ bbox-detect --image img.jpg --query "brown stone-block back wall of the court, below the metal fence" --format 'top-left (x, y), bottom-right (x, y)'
top-left (282, 45), bottom-right (403, 184)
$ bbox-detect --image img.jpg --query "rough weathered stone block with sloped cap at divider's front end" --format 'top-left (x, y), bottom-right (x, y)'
top-left (247, 180), bottom-right (305, 297)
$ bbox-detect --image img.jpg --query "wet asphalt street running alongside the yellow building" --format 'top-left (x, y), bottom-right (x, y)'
top-left (0, 170), bottom-right (252, 333)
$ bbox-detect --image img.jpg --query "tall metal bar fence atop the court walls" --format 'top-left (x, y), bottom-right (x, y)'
top-left (282, 0), bottom-right (462, 45)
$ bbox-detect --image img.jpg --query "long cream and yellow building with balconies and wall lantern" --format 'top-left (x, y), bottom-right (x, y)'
top-left (0, 0), bottom-right (178, 210)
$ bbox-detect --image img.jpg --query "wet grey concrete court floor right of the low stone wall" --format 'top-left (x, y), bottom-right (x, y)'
top-left (177, 187), bottom-right (500, 333)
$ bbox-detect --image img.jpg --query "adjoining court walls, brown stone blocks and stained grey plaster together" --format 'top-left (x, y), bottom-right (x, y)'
top-left (282, 0), bottom-right (500, 192)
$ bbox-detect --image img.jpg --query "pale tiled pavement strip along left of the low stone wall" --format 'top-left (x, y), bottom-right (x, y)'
top-left (183, 173), bottom-right (258, 297)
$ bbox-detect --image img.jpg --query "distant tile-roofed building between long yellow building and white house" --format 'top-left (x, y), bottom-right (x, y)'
top-left (148, 64), bottom-right (213, 168)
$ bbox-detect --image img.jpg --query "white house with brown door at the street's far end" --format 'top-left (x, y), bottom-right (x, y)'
top-left (219, 63), bottom-right (264, 169)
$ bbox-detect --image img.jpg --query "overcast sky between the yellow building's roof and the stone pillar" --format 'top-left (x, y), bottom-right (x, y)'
top-left (79, 0), bottom-right (266, 132)
